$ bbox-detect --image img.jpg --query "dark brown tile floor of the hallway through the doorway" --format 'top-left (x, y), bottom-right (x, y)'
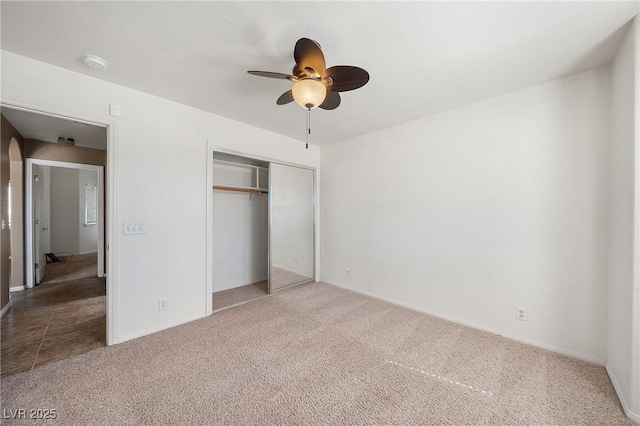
top-left (0, 272), bottom-right (106, 376)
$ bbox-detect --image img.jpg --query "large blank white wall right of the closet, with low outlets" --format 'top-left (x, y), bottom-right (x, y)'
top-left (320, 68), bottom-right (610, 363)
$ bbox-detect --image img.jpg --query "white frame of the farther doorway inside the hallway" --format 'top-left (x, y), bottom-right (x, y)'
top-left (24, 158), bottom-right (105, 288)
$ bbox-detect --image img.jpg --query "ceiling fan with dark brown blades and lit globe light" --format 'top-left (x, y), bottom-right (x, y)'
top-left (247, 38), bottom-right (369, 110)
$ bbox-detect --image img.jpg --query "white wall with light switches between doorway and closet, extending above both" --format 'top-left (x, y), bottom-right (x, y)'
top-left (2, 51), bottom-right (319, 343)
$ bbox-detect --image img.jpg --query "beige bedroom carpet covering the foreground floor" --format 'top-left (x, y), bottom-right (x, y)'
top-left (2, 283), bottom-right (632, 425)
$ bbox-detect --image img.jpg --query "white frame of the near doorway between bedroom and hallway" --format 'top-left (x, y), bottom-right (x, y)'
top-left (0, 99), bottom-right (119, 346)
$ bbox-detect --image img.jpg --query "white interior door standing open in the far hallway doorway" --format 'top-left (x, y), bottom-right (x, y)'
top-left (31, 164), bottom-right (48, 284)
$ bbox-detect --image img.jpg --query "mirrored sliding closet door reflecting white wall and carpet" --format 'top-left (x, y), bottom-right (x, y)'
top-left (269, 163), bottom-right (315, 292)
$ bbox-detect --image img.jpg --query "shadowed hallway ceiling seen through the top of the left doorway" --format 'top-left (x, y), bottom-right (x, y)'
top-left (1, 108), bottom-right (107, 149)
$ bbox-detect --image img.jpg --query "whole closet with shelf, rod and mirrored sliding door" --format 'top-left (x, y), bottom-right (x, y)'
top-left (212, 151), bottom-right (315, 311)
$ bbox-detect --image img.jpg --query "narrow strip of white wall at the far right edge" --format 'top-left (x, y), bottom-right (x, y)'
top-left (607, 18), bottom-right (640, 421)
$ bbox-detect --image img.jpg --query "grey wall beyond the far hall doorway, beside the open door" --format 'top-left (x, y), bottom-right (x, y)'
top-left (45, 166), bottom-right (80, 254)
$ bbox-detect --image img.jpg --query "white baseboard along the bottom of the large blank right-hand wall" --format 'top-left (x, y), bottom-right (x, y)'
top-left (324, 281), bottom-right (605, 366)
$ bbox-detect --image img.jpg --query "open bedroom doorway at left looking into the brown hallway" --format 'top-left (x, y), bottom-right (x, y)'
top-left (2, 105), bottom-right (115, 376)
